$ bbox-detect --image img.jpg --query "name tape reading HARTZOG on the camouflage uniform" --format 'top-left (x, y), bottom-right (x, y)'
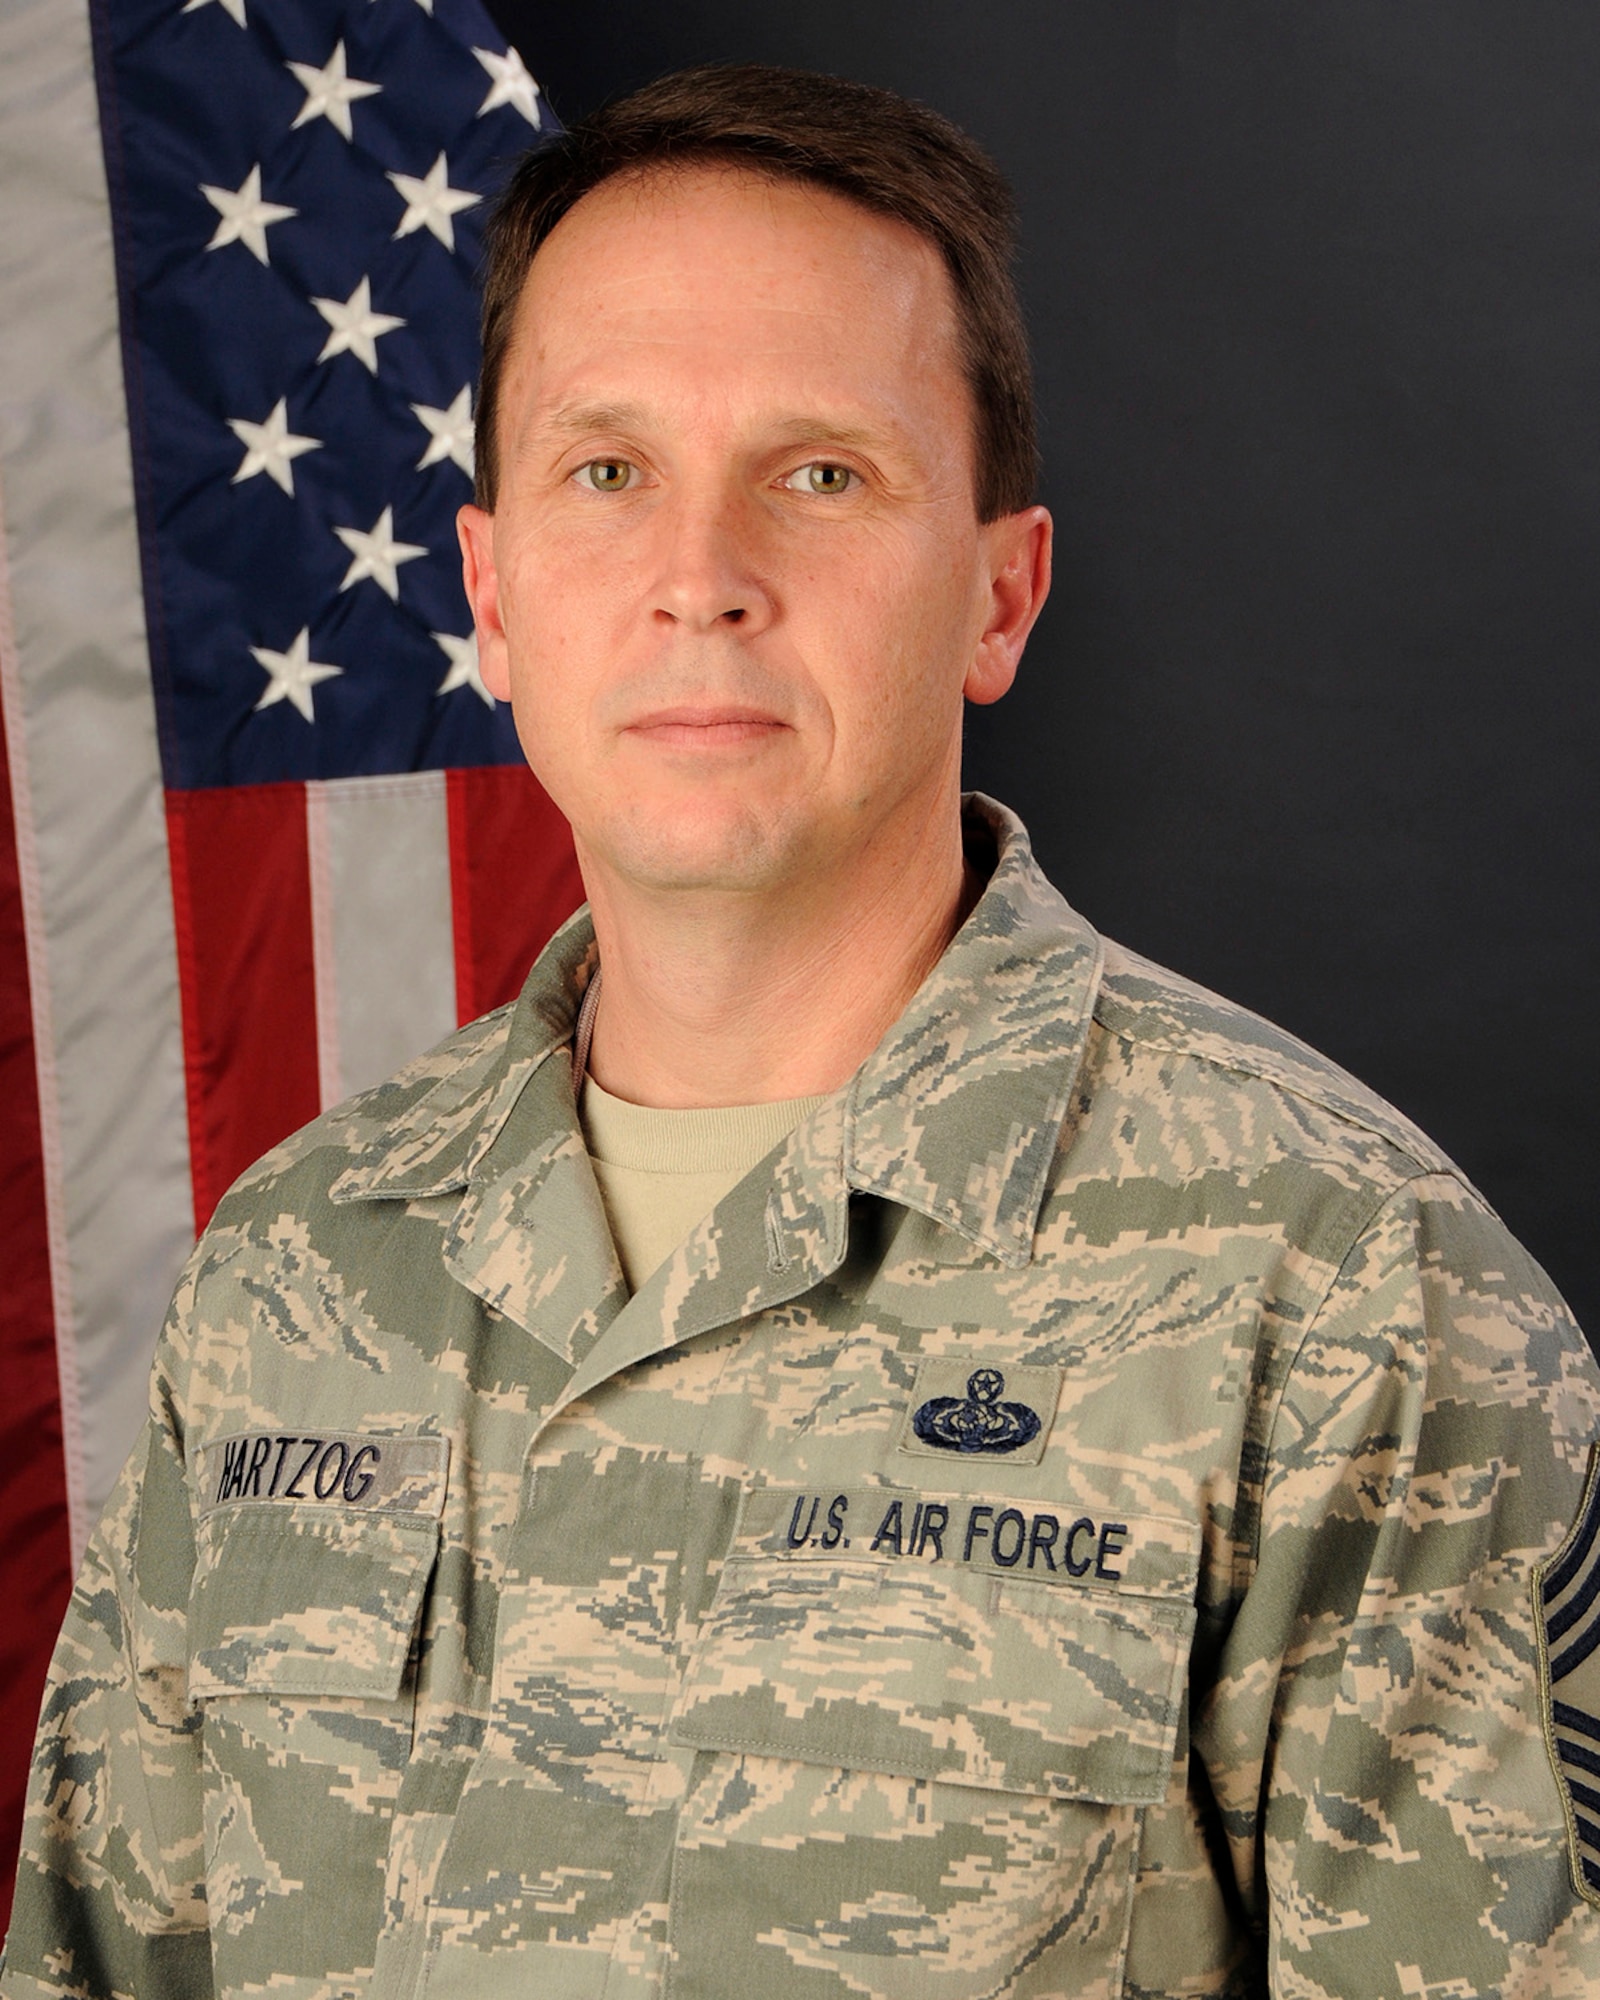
top-left (196, 1430), bottom-right (450, 1516)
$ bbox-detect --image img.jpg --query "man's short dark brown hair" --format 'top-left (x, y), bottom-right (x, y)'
top-left (476, 64), bottom-right (1038, 520)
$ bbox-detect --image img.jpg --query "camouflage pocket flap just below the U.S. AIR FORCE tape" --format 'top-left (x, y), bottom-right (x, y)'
top-left (672, 1494), bottom-right (1196, 1804)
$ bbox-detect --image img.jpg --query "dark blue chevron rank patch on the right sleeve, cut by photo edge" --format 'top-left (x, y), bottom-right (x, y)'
top-left (1534, 1446), bottom-right (1600, 1908)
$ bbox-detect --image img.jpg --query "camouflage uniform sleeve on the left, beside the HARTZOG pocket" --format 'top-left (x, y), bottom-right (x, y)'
top-left (0, 1290), bottom-right (212, 2000)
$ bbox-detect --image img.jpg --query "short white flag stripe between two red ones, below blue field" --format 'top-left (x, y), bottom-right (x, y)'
top-left (306, 770), bottom-right (456, 1110)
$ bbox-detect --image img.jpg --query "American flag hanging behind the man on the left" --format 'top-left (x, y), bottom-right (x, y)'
top-left (0, 0), bottom-right (580, 1920)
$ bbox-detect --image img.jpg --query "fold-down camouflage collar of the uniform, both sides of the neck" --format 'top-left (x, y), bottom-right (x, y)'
top-left (330, 794), bottom-right (1102, 1268)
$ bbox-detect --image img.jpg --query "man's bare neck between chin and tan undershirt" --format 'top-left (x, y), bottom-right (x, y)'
top-left (580, 814), bottom-right (982, 1110)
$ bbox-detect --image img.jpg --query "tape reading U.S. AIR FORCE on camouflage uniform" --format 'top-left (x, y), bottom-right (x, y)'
top-left (734, 1486), bottom-right (1200, 1596)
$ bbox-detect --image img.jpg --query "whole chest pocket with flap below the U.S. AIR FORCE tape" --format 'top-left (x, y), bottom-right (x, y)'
top-left (670, 1494), bottom-right (1198, 2000)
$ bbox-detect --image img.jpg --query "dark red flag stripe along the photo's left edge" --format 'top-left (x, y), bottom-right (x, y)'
top-left (0, 692), bottom-right (72, 1930)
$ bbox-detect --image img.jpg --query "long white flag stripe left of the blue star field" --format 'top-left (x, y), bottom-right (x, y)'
top-left (0, 0), bottom-right (194, 1556)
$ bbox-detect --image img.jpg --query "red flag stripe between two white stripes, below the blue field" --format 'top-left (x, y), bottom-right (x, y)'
top-left (166, 784), bottom-right (322, 1230)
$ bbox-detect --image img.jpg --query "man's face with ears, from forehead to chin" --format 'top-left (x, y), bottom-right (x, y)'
top-left (462, 170), bottom-right (1048, 892)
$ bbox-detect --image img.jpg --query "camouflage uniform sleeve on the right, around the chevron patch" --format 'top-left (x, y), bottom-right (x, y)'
top-left (1196, 1176), bottom-right (1600, 2000)
